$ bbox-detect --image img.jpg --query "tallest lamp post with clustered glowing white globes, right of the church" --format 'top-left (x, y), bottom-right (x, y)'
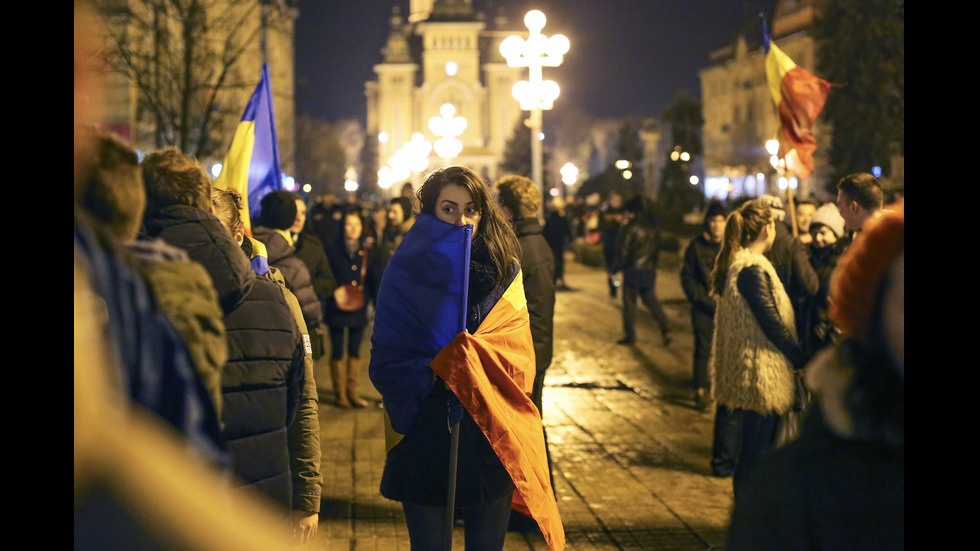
top-left (500, 10), bottom-right (569, 192)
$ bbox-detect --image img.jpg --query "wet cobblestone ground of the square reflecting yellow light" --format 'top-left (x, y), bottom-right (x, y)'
top-left (311, 256), bottom-right (731, 551)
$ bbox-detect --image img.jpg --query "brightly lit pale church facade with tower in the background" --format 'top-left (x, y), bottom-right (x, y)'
top-left (365, 0), bottom-right (527, 190)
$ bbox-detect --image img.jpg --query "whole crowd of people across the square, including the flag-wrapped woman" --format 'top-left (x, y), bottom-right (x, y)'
top-left (73, 8), bottom-right (904, 550)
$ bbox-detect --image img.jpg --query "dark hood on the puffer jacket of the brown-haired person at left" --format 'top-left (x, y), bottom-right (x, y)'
top-left (143, 205), bottom-right (255, 312)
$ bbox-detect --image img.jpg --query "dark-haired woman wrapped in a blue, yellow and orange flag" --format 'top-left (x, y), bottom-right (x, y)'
top-left (370, 167), bottom-right (565, 551)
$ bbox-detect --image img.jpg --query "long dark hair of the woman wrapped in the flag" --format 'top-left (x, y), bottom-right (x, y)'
top-left (417, 166), bottom-right (520, 285)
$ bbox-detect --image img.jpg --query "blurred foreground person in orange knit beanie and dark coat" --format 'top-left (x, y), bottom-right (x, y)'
top-left (725, 202), bottom-right (905, 551)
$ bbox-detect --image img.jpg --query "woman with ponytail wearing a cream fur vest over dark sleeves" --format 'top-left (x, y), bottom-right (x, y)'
top-left (710, 200), bottom-right (806, 499)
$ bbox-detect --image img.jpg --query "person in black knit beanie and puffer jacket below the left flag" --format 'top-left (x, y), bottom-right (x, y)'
top-left (252, 191), bottom-right (323, 334)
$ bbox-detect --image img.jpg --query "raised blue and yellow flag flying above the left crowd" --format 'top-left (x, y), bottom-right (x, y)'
top-left (214, 64), bottom-right (282, 235)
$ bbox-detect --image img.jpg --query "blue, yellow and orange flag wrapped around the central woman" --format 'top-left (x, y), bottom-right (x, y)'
top-left (370, 214), bottom-right (565, 551)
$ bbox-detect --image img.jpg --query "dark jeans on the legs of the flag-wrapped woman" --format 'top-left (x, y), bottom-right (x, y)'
top-left (402, 494), bottom-right (512, 551)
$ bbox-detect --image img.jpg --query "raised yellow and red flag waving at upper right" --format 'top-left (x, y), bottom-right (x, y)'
top-left (762, 19), bottom-right (830, 178)
